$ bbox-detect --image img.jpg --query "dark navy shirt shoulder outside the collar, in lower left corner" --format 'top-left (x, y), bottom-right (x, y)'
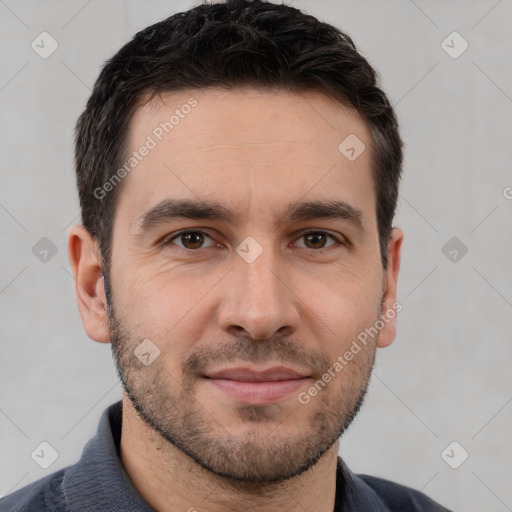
top-left (0, 468), bottom-right (68, 512)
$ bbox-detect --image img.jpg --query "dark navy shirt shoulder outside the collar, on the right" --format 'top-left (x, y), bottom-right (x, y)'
top-left (356, 474), bottom-right (450, 512)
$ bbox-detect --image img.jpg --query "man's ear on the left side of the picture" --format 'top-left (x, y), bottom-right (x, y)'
top-left (68, 225), bottom-right (110, 343)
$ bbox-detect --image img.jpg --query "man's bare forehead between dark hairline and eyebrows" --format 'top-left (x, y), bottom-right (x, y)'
top-left (119, 88), bottom-right (375, 228)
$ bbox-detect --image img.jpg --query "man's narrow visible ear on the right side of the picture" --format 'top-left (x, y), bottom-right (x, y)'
top-left (377, 228), bottom-right (404, 348)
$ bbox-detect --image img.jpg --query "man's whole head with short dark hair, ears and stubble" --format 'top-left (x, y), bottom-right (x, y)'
top-left (68, 0), bottom-right (402, 483)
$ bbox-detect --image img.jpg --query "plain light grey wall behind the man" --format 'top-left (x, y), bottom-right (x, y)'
top-left (0, 0), bottom-right (512, 512)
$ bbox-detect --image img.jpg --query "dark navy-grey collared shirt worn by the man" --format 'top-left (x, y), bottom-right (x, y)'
top-left (0, 401), bottom-right (450, 512)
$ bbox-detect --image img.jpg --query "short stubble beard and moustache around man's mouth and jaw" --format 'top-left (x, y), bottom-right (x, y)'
top-left (109, 307), bottom-right (375, 490)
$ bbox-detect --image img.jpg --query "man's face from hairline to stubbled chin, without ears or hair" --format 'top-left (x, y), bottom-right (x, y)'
top-left (109, 89), bottom-right (391, 482)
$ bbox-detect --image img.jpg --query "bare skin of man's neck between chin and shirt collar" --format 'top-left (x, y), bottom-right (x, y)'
top-left (120, 394), bottom-right (339, 512)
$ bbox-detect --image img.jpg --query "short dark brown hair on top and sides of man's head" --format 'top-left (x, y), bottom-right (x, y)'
top-left (75, 0), bottom-right (403, 278)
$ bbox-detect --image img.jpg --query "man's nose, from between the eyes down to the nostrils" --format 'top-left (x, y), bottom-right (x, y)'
top-left (218, 243), bottom-right (300, 340)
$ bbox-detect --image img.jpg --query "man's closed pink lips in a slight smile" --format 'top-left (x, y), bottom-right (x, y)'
top-left (203, 366), bottom-right (312, 405)
